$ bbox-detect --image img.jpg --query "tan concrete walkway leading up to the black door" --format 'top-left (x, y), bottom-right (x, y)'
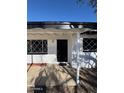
top-left (27, 64), bottom-right (76, 93)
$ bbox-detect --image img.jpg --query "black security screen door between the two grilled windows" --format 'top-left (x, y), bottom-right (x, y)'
top-left (57, 40), bottom-right (68, 62)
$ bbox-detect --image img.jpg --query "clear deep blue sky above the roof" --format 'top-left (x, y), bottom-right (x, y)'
top-left (27, 0), bottom-right (97, 22)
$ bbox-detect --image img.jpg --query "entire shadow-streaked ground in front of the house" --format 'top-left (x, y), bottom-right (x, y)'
top-left (27, 64), bottom-right (97, 93)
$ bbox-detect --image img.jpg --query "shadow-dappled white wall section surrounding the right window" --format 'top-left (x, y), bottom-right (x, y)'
top-left (71, 34), bottom-right (97, 68)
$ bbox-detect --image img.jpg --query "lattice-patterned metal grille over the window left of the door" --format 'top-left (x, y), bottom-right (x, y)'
top-left (27, 40), bottom-right (48, 54)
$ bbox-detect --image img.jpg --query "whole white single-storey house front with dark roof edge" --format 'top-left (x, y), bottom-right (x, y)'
top-left (27, 22), bottom-right (97, 68)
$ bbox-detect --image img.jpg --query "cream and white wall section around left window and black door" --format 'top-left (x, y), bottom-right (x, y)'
top-left (27, 33), bottom-right (72, 63)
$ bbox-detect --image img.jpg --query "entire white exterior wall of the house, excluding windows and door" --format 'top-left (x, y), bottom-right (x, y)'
top-left (27, 33), bottom-right (97, 68)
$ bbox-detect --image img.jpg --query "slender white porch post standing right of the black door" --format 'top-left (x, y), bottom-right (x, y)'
top-left (76, 32), bottom-right (80, 85)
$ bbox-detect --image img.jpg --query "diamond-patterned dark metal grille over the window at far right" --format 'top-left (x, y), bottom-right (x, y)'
top-left (83, 38), bottom-right (97, 52)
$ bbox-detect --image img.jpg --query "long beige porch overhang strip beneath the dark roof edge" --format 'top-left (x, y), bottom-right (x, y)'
top-left (27, 28), bottom-right (96, 34)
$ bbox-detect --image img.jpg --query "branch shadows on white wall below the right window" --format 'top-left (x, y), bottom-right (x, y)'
top-left (71, 43), bottom-right (97, 68)
